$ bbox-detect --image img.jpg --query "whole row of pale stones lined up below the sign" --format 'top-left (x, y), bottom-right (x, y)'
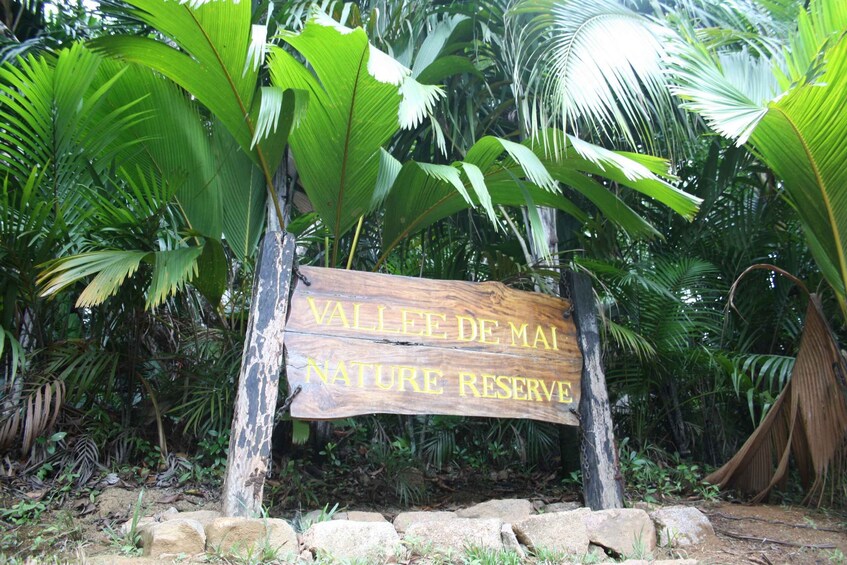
top-left (124, 500), bottom-right (708, 565)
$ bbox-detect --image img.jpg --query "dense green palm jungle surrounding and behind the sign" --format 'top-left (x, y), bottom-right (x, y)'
top-left (0, 0), bottom-right (847, 560)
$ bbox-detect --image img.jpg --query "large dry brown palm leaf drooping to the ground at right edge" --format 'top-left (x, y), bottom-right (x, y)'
top-left (706, 294), bottom-right (847, 505)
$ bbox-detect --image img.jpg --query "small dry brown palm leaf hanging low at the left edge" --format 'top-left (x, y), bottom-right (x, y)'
top-left (0, 380), bottom-right (65, 453)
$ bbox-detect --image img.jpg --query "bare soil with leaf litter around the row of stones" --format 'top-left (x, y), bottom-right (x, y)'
top-left (0, 485), bottom-right (847, 565)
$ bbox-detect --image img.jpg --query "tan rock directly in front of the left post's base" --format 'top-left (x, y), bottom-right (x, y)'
top-left (205, 517), bottom-right (300, 558)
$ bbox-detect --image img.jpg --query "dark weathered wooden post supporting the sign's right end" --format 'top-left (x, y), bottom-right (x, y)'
top-left (562, 271), bottom-right (623, 510)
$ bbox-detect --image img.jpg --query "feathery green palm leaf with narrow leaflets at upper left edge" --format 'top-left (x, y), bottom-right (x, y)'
top-left (0, 44), bottom-right (143, 197)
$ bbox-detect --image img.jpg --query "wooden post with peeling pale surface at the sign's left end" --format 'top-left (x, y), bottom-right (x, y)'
top-left (222, 231), bottom-right (295, 517)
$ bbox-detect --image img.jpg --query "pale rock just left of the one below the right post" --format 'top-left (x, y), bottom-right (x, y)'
top-left (512, 508), bottom-right (591, 557)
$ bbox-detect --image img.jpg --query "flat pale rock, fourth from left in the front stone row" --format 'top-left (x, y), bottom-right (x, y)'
top-left (403, 517), bottom-right (503, 554)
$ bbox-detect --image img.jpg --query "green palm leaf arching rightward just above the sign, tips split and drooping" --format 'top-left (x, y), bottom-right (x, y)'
top-left (383, 130), bottom-right (700, 266)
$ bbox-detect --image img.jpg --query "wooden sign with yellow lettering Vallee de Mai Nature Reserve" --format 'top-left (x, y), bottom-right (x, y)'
top-left (284, 267), bottom-right (582, 425)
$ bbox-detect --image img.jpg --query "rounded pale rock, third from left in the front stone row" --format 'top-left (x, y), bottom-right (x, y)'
top-left (302, 520), bottom-right (402, 563)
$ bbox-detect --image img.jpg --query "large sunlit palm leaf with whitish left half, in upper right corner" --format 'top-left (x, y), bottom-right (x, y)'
top-left (674, 4), bottom-right (847, 317)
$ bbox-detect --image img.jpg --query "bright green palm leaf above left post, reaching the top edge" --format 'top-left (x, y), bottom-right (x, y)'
top-left (92, 0), bottom-right (294, 229)
